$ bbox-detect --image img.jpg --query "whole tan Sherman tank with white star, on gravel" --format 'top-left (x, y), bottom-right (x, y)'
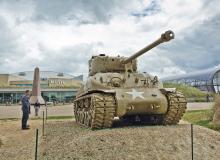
top-left (74, 31), bottom-right (187, 129)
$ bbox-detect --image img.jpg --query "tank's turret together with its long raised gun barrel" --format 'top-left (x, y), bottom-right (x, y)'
top-left (89, 31), bottom-right (174, 76)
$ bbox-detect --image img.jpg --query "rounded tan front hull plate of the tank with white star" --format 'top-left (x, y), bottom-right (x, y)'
top-left (115, 88), bottom-right (168, 117)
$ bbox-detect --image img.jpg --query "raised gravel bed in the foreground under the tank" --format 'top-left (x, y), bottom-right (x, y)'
top-left (44, 121), bottom-right (220, 160)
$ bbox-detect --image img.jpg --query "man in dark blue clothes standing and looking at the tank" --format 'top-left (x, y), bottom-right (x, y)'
top-left (21, 90), bottom-right (31, 130)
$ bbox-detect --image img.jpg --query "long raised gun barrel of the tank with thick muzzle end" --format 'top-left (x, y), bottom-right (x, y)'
top-left (123, 30), bottom-right (174, 64)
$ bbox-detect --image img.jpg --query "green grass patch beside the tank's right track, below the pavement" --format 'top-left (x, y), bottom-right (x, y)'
top-left (183, 109), bottom-right (219, 130)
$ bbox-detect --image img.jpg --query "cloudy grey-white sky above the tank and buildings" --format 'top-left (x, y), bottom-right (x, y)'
top-left (0, 0), bottom-right (220, 77)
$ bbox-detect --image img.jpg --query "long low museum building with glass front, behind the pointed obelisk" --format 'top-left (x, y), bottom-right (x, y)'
top-left (0, 71), bottom-right (83, 103)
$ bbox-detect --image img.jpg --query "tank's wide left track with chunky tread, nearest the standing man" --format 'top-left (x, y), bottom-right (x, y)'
top-left (74, 93), bottom-right (116, 129)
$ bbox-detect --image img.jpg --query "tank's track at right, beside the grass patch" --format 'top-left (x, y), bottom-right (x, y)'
top-left (162, 92), bottom-right (187, 125)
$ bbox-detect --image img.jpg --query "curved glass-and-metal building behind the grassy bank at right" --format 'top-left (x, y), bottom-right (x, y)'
top-left (162, 67), bottom-right (220, 93)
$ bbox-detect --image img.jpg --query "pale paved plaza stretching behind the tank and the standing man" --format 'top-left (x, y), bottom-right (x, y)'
top-left (0, 103), bottom-right (213, 119)
